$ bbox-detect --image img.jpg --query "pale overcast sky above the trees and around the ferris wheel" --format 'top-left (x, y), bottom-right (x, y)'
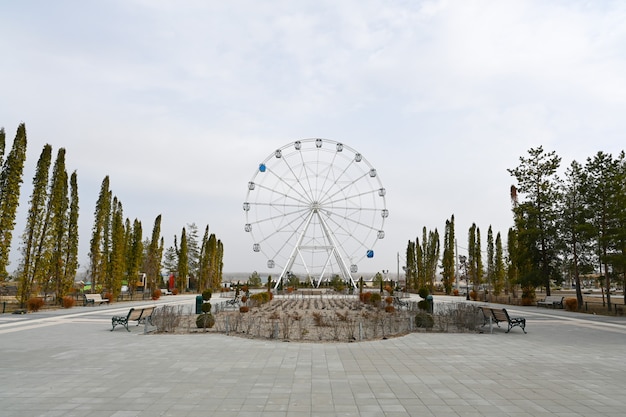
top-left (0, 0), bottom-right (626, 278)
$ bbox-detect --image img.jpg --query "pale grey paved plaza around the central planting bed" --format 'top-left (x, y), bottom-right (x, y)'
top-left (0, 296), bottom-right (626, 417)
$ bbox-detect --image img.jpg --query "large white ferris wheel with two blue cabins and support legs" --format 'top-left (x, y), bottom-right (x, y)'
top-left (243, 138), bottom-right (389, 286)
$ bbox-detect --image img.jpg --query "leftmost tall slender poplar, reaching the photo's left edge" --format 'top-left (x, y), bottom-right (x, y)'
top-left (0, 123), bottom-right (27, 281)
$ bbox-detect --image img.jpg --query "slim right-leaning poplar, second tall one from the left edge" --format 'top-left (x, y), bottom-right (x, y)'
top-left (18, 144), bottom-right (52, 307)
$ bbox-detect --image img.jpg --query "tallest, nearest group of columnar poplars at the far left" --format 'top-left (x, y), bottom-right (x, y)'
top-left (0, 123), bottom-right (78, 305)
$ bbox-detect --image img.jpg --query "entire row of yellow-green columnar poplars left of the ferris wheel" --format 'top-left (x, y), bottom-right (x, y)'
top-left (0, 123), bottom-right (224, 305)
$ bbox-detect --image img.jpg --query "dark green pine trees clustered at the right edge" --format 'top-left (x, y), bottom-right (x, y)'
top-left (508, 147), bottom-right (626, 310)
